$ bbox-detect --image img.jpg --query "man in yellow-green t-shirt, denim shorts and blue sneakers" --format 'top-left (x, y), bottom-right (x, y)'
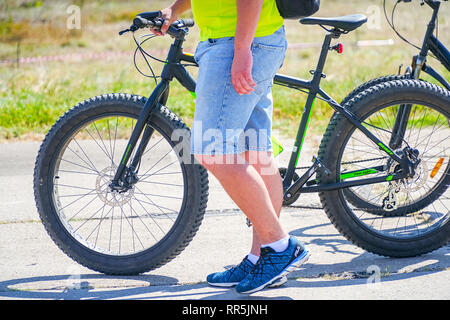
top-left (154, 0), bottom-right (309, 293)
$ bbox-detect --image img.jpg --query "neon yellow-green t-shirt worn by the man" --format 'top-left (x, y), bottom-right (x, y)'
top-left (191, 0), bottom-right (284, 41)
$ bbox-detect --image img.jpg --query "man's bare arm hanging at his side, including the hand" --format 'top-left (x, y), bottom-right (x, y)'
top-left (231, 0), bottom-right (263, 94)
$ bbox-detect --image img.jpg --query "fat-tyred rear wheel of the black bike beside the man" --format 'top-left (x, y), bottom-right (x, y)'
top-left (318, 80), bottom-right (450, 257)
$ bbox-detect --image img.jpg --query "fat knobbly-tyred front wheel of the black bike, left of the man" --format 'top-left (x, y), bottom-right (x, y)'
top-left (34, 94), bottom-right (208, 275)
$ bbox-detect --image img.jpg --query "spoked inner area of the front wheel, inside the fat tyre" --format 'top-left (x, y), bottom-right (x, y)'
top-left (49, 111), bottom-right (185, 255)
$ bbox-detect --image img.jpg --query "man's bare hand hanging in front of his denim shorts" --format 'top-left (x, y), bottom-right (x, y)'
top-left (231, 48), bottom-right (256, 94)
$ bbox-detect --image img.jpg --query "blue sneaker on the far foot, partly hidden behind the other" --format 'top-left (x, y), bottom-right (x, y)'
top-left (206, 257), bottom-right (287, 288)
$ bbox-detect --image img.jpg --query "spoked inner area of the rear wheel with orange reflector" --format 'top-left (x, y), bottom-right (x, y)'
top-left (340, 100), bottom-right (450, 238)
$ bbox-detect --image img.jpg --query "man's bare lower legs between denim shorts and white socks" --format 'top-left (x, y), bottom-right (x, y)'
top-left (196, 154), bottom-right (287, 245)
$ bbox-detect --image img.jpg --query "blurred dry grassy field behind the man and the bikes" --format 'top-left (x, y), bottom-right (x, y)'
top-left (0, 0), bottom-right (450, 141)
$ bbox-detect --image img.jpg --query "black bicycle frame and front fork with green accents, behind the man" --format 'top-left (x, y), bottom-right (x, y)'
top-left (110, 26), bottom-right (410, 198)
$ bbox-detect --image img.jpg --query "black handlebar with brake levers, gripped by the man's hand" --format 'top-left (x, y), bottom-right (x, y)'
top-left (119, 11), bottom-right (195, 37)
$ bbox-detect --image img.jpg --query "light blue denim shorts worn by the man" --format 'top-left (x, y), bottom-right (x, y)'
top-left (191, 27), bottom-right (287, 155)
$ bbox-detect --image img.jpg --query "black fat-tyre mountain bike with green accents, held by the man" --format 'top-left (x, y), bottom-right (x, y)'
top-left (34, 12), bottom-right (450, 274)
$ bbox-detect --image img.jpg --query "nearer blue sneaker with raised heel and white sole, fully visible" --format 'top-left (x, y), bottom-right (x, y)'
top-left (236, 237), bottom-right (310, 294)
